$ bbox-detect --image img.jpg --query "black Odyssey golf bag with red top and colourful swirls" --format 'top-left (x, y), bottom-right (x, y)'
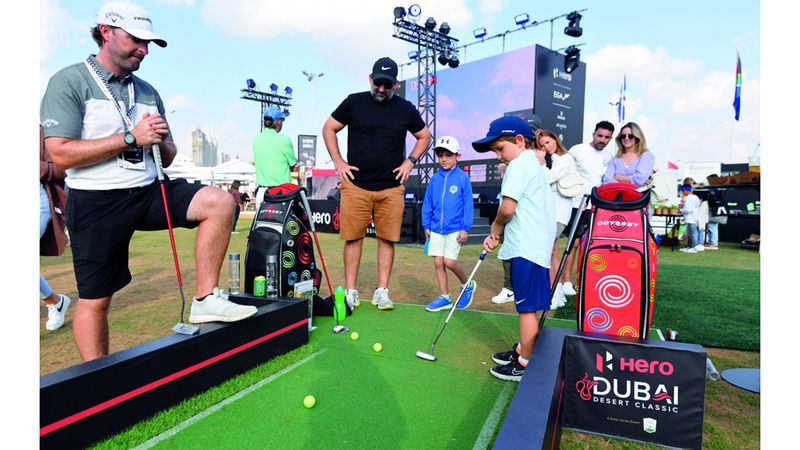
top-left (244, 184), bottom-right (322, 297)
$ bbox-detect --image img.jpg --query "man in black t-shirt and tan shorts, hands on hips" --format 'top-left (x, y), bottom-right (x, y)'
top-left (322, 58), bottom-right (431, 311)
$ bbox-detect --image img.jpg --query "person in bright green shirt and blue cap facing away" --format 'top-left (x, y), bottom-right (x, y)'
top-left (253, 106), bottom-right (298, 212)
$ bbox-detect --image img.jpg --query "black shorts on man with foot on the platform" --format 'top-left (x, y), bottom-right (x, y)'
top-left (67, 178), bottom-right (205, 299)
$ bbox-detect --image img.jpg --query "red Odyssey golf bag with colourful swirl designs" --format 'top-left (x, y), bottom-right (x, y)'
top-left (576, 183), bottom-right (658, 339)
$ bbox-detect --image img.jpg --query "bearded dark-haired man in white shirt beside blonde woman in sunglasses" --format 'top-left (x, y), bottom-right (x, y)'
top-left (559, 120), bottom-right (614, 295)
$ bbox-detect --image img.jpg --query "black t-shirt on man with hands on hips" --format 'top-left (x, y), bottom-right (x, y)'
top-left (331, 92), bottom-right (425, 191)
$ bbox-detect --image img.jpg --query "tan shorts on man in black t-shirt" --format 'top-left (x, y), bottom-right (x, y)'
top-left (339, 179), bottom-right (406, 242)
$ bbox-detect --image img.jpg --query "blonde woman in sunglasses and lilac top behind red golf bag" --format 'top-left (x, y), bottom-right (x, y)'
top-left (603, 122), bottom-right (656, 186)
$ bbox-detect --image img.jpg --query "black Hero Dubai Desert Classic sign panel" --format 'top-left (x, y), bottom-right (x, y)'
top-left (564, 336), bottom-right (706, 448)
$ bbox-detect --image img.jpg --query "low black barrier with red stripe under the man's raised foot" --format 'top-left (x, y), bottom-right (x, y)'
top-left (39, 300), bottom-right (308, 449)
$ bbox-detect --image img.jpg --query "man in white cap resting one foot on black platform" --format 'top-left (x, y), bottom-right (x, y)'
top-left (40, 1), bottom-right (257, 361)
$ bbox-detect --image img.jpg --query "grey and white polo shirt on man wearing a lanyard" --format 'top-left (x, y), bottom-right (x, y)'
top-left (40, 55), bottom-right (172, 190)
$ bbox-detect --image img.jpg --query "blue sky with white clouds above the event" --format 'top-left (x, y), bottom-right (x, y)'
top-left (39, 0), bottom-right (761, 169)
